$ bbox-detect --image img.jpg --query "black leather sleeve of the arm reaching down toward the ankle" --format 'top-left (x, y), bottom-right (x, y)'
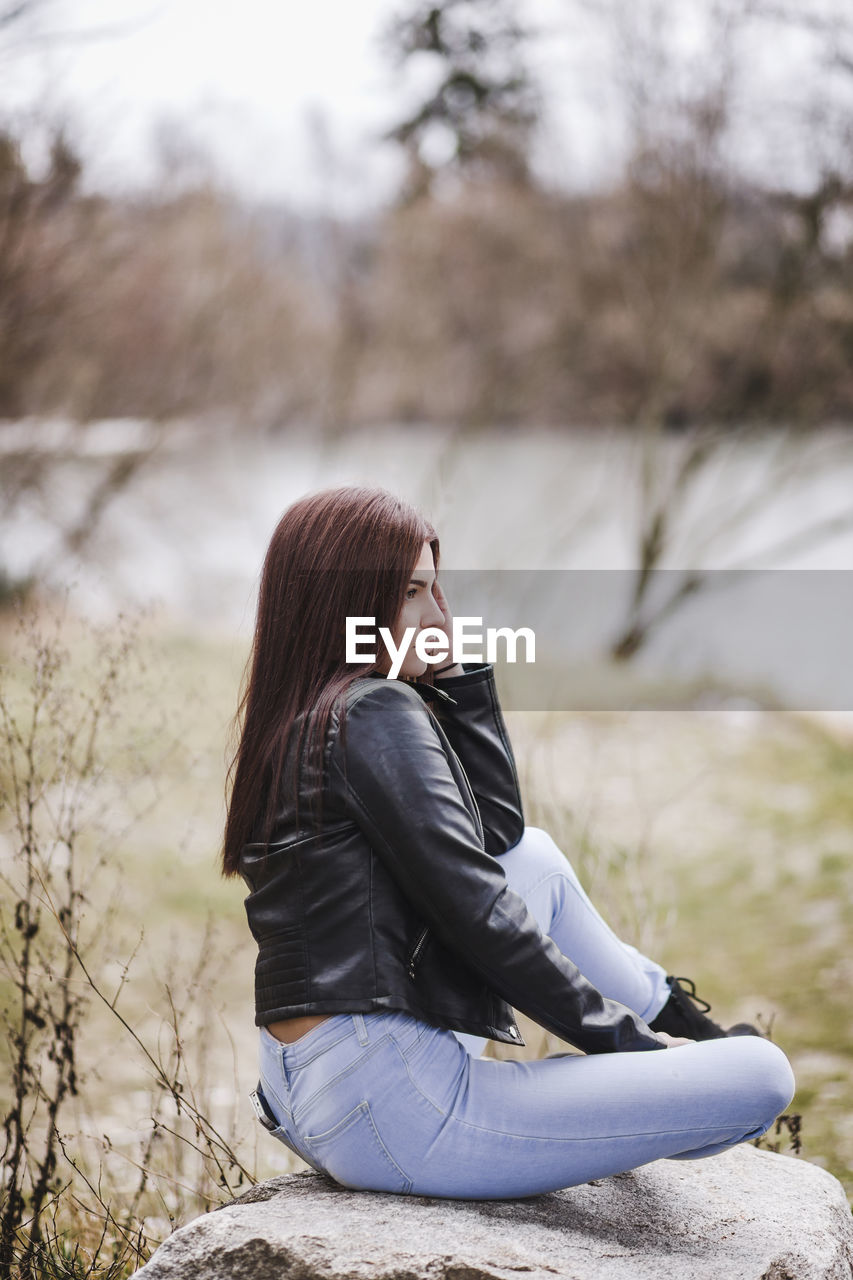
top-left (329, 680), bottom-right (663, 1053)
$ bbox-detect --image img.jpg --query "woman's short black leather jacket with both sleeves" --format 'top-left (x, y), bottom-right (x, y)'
top-left (240, 664), bottom-right (662, 1053)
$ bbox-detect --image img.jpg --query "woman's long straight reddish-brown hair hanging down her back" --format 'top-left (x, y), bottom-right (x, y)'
top-left (222, 485), bottom-right (439, 876)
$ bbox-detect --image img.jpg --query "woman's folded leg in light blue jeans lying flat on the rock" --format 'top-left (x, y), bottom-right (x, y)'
top-left (409, 1013), bottom-right (794, 1198)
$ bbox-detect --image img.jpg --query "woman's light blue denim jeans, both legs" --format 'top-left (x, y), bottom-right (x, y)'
top-left (252, 827), bottom-right (794, 1199)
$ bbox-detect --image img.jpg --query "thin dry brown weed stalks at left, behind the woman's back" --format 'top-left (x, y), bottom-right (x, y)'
top-left (0, 611), bottom-right (262, 1280)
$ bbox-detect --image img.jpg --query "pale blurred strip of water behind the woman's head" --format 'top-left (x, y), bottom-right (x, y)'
top-left (0, 421), bottom-right (853, 710)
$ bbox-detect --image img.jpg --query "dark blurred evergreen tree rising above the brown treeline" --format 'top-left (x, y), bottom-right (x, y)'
top-left (380, 0), bottom-right (539, 204)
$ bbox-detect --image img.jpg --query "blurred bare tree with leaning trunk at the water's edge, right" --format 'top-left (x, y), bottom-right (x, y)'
top-left (560, 0), bottom-right (853, 660)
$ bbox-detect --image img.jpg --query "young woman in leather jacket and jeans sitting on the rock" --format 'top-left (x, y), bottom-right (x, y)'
top-left (223, 486), bottom-right (793, 1199)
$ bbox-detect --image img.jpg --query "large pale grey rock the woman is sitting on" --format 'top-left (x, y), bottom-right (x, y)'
top-left (137, 1147), bottom-right (853, 1280)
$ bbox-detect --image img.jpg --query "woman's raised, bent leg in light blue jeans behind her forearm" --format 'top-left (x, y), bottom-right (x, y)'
top-left (455, 827), bottom-right (670, 1057)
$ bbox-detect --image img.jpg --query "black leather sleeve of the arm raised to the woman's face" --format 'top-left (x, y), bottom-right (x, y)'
top-left (433, 663), bottom-right (524, 855)
